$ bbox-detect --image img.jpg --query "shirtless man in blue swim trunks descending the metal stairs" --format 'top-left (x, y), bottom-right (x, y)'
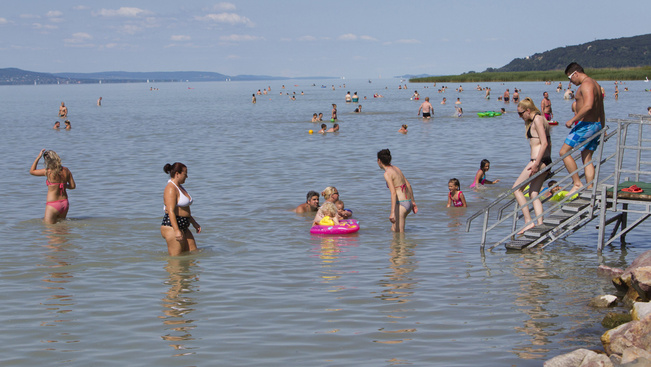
top-left (560, 62), bottom-right (606, 196)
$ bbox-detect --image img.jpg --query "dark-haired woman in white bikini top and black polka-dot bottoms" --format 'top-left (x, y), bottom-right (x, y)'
top-left (160, 162), bottom-right (201, 256)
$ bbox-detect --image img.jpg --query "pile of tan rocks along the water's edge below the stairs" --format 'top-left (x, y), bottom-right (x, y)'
top-left (543, 250), bottom-right (651, 367)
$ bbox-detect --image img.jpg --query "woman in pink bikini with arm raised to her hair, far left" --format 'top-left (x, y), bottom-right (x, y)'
top-left (29, 149), bottom-right (77, 224)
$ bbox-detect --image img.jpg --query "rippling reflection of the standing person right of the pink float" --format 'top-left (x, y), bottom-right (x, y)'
top-left (374, 233), bottom-right (418, 344)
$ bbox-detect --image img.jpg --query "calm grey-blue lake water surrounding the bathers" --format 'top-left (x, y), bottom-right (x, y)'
top-left (0, 79), bottom-right (651, 366)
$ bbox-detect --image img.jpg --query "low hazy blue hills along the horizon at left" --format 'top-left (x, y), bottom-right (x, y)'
top-left (0, 68), bottom-right (336, 85)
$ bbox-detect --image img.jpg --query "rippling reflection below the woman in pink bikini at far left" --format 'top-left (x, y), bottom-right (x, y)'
top-left (40, 222), bottom-right (79, 351)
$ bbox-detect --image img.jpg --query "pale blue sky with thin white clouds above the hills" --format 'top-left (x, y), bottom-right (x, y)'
top-left (0, 0), bottom-right (651, 78)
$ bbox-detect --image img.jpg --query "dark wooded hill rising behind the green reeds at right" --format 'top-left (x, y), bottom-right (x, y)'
top-left (486, 34), bottom-right (651, 72)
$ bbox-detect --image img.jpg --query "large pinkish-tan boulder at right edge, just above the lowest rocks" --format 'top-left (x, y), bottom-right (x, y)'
top-left (601, 315), bottom-right (651, 355)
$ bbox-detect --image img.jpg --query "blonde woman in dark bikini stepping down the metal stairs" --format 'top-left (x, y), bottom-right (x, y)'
top-left (513, 97), bottom-right (552, 234)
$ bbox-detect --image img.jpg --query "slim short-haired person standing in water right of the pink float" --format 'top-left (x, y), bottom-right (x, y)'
top-left (377, 149), bottom-right (418, 232)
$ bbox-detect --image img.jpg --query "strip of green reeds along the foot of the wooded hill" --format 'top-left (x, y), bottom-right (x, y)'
top-left (409, 66), bottom-right (651, 83)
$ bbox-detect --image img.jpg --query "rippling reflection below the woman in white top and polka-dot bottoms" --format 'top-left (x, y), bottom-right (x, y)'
top-left (160, 258), bottom-right (199, 357)
